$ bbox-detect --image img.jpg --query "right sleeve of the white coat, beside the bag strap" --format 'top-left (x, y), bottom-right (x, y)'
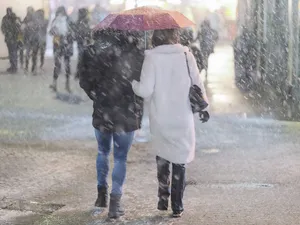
top-left (187, 52), bottom-right (209, 103)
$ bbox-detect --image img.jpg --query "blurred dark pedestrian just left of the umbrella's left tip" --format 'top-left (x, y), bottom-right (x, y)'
top-left (75, 8), bottom-right (91, 78)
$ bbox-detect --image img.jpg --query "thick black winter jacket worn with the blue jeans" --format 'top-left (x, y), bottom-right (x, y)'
top-left (79, 36), bottom-right (144, 132)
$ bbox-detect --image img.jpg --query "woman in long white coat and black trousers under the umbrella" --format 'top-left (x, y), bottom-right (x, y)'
top-left (132, 29), bottom-right (207, 217)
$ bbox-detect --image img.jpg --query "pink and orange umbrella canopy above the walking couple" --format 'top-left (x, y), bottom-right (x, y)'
top-left (94, 7), bottom-right (195, 31)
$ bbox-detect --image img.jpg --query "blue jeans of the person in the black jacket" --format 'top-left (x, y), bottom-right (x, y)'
top-left (95, 129), bottom-right (134, 195)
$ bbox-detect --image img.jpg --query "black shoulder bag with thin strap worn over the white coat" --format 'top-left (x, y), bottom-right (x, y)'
top-left (184, 52), bottom-right (208, 113)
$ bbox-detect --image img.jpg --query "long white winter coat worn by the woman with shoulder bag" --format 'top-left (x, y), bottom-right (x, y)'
top-left (132, 44), bottom-right (207, 164)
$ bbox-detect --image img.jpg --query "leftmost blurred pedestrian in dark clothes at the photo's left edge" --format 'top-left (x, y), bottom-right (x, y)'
top-left (1, 8), bottom-right (20, 73)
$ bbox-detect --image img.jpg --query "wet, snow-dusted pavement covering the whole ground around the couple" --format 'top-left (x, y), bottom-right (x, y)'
top-left (0, 46), bottom-right (300, 225)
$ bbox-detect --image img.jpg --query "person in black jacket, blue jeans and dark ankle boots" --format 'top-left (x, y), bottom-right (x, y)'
top-left (79, 31), bottom-right (144, 218)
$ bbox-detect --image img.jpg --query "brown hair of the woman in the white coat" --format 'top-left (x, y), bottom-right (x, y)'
top-left (152, 29), bottom-right (180, 47)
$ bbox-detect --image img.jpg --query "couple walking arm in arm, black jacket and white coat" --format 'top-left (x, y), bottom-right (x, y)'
top-left (80, 29), bottom-right (207, 218)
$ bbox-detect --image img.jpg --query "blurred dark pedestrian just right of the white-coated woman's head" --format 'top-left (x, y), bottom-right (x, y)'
top-left (196, 20), bottom-right (219, 78)
